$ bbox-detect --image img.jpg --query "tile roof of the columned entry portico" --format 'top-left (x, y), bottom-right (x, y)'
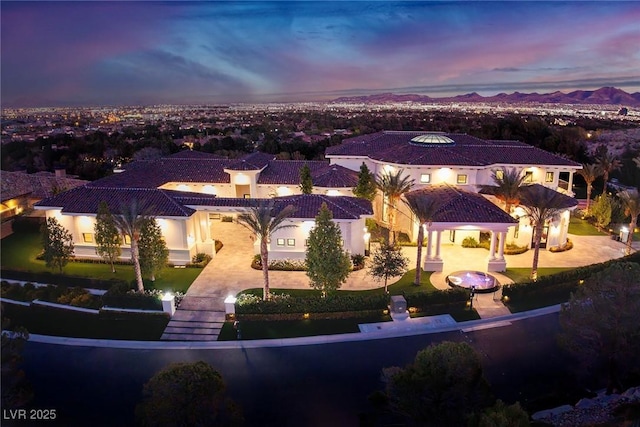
top-left (405, 185), bottom-right (518, 224)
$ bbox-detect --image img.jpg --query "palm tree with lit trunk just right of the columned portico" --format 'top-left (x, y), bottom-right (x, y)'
top-left (520, 184), bottom-right (575, 281)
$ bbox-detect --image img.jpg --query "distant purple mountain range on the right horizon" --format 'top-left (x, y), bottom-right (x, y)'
top-left (332, 87), bottom-right (640, 107)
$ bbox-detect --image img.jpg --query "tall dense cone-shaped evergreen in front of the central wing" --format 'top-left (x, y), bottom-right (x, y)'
top-left (306, 203), bottom-right (351, 296)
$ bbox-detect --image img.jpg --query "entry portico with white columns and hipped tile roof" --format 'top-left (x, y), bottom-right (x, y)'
top-left (408, 185), bottom-right (518, 271)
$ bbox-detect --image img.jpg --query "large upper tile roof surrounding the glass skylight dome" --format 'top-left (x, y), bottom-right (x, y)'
top-left (325, 131), bottom-right (580, 167)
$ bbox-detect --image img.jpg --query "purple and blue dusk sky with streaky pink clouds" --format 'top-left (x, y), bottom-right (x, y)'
top-left (0, 0), bottom-right (640, 106)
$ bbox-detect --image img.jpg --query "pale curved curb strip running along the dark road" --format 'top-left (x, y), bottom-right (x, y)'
top-left (29, 304), bottom-right (561, 350)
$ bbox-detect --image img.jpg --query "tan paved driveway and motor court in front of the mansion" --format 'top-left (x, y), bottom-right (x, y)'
top-left (162, 227), bottom-right (624, 341)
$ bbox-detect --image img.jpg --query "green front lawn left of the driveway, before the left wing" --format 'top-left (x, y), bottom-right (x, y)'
top-left (0, 233), bottom-right (202, 292)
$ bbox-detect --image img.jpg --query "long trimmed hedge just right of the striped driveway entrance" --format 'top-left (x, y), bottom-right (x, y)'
top-left (236, 294), bottom-right (389, 315)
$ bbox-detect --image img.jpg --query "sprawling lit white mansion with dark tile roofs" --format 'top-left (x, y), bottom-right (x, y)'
top-left (36, 131), bottom-right (581, 271)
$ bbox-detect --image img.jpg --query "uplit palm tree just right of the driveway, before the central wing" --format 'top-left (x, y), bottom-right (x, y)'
top-left (238, 200), bottom-right (295, 301)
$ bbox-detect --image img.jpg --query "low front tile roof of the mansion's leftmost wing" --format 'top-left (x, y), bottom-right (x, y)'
top-left (36, 185), bottom-right (195, 217)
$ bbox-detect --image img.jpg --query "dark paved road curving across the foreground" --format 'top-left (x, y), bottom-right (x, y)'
top-left (20, 314), bottom-right (567, 426)
